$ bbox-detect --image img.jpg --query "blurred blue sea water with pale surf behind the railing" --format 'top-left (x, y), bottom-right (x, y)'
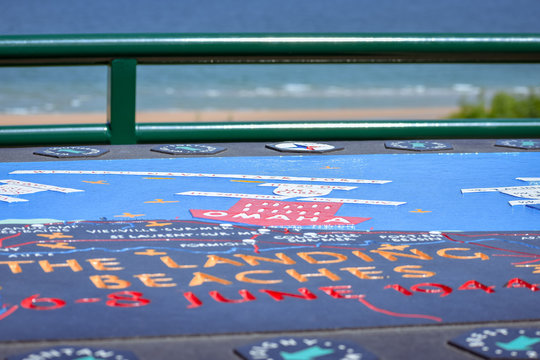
top-left (0, 0), bottom-right (540, 114)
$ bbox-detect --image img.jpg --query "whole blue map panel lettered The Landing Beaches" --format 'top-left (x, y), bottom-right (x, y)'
top-left (0, 153), bottom-right (540, 341)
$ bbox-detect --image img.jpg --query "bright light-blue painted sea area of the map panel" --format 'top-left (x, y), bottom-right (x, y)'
top-left (0, 153), bottom-right (540, 231)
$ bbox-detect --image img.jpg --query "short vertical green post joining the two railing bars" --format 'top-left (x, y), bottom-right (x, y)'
top-left (107, 59), bottom-right (137, 145)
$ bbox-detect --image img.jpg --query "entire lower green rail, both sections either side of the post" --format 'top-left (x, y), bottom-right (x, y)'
top-left (0, 119), bottom-right (540, 146)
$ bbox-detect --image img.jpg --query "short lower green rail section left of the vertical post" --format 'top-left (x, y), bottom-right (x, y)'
top-left (0, 124), bottom-right (111, 146)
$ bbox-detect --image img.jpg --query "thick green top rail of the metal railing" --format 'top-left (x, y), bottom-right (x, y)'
top-left (0, 34), bottom-right (540, 66)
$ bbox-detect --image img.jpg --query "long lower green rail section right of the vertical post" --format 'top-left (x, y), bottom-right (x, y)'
top-left (136, 119), bottom-right (540, 143)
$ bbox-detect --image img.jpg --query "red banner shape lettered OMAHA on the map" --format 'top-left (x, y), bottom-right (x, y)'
top-left (190, 199), bottom-right (371, 226)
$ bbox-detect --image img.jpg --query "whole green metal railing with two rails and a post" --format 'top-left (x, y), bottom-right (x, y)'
top-left (0, 34), bottom-right (540, 145)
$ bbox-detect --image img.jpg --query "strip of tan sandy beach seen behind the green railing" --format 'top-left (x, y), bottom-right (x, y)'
top-left (0, 107), bottom-right (456, 126)
